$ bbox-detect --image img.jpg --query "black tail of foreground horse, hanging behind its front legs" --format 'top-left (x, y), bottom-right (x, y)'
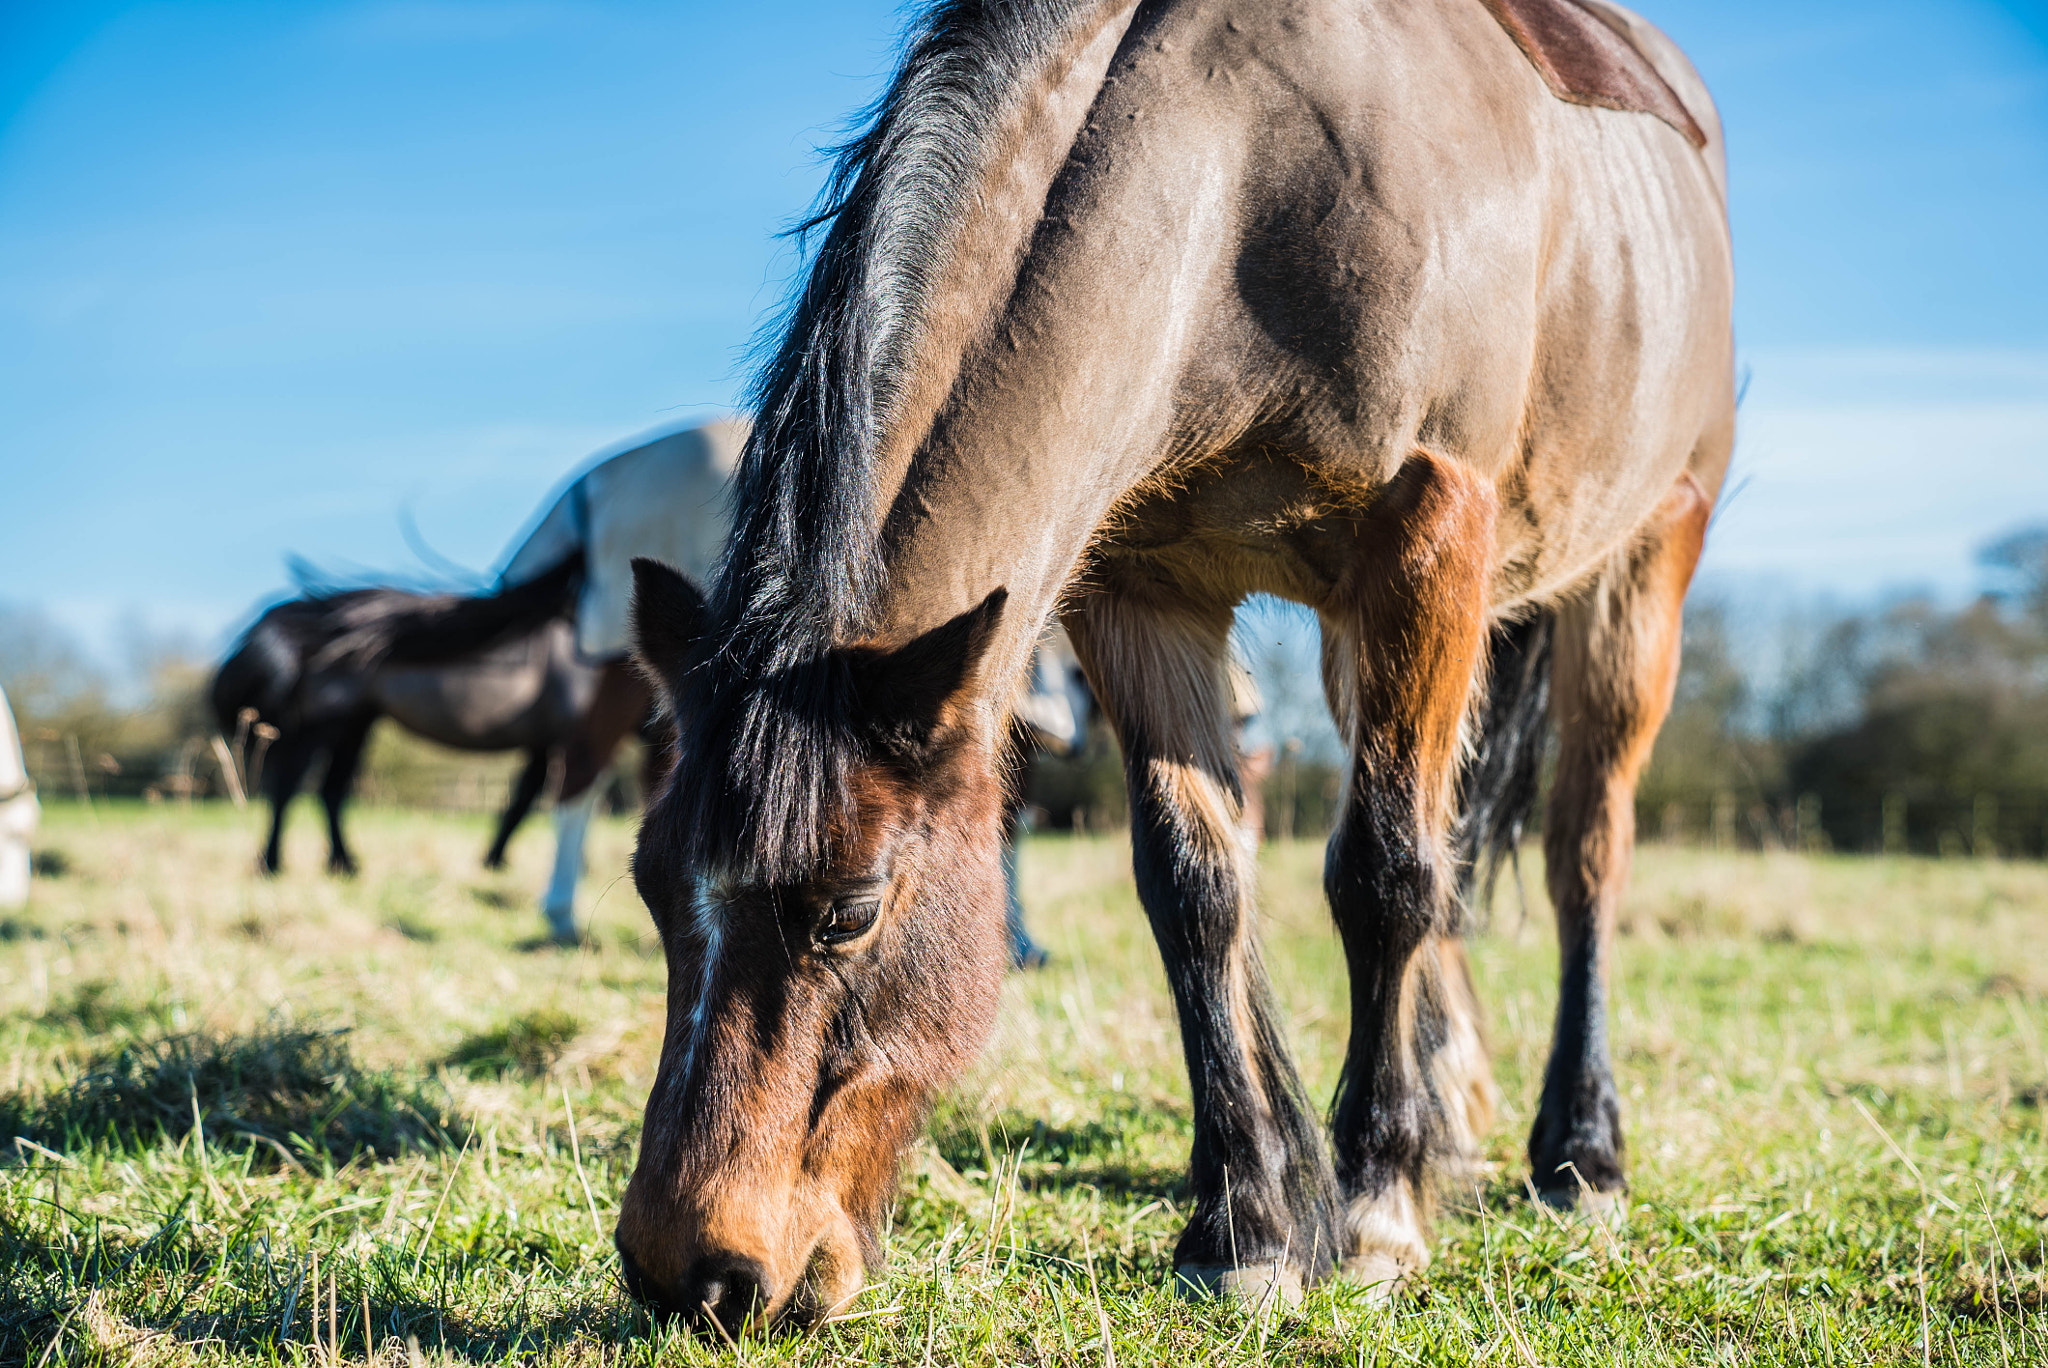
top-left (1458, 608), bottom-right (1556, 907)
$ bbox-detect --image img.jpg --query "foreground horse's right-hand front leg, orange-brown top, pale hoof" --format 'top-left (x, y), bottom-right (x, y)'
top-left (1321, 455), bottom-right (1497, 1292)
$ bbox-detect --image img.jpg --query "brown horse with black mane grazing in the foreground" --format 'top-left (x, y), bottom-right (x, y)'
top-left (616, 0), bottom-right (1735, 1327)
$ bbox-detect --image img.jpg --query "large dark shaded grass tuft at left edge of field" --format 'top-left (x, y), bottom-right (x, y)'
top-left (0, 1026), bottom-right (465, 1163)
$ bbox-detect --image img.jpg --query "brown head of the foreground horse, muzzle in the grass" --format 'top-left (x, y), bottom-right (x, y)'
top-left (616, 561), bottom-right (1006, 1329)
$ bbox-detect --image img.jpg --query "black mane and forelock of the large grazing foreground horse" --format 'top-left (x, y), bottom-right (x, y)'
top-left (674, 0), bottom-right (1094, 879)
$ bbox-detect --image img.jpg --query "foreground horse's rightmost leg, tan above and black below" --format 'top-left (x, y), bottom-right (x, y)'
top-left (1530, 475), bottom-right (1712, 1212)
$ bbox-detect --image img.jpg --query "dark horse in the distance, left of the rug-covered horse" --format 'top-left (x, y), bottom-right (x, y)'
top-left (211, 561), bottom-right (598, 874)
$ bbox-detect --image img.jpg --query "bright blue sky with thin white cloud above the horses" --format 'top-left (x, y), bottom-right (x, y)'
top-left (0, 0), bottom-right (2048, 663)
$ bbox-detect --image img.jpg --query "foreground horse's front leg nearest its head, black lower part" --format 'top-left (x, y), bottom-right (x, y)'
top-left (1067, 584), bottom-right (1337, 1305)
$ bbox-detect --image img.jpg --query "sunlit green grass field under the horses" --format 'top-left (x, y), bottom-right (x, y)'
top-left (0, 805), bottom-right (2048, 1368)
